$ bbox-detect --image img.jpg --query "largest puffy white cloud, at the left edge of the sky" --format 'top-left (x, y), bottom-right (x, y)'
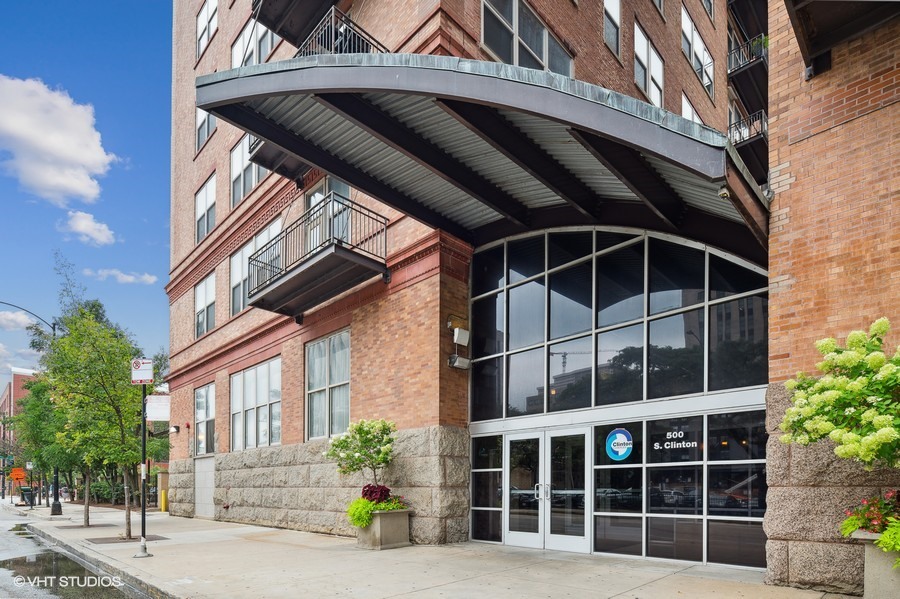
top-left (0, 75), bottom-right (118, 207)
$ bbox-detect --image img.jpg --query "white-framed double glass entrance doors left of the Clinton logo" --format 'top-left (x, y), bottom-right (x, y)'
top-left (504, 429), bottom-right (590, 553)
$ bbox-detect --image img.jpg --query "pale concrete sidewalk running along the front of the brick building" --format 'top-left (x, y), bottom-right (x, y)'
top-left (2, 504), bottom-right (845, 599)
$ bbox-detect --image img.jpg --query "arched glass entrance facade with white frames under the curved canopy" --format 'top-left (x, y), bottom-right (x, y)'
top-left (470, 229), bottom-right (768, 567)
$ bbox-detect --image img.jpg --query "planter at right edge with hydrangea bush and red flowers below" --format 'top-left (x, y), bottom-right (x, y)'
top-left (781, 318), bottom-right (900, 596)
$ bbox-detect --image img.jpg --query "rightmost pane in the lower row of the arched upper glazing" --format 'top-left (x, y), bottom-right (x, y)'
top-left (709, 296), bottom-right (769, 391)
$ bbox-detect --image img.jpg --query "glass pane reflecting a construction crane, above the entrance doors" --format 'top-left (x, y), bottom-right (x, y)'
top-left (547, 337), bottom-right (593, 412)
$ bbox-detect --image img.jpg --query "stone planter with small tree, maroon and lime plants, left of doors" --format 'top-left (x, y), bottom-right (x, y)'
top-left (325, 420), bottom-right (410, 549)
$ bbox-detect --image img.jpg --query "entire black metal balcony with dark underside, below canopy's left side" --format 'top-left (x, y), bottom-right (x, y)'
top-left (249, 192), bottom-right (389, 322)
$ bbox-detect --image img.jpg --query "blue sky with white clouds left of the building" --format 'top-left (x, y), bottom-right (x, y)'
top-left (0, 0), bottom-right (172, 388)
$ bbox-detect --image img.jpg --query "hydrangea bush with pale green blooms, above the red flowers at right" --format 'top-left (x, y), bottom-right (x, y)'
top-left (781, 318), bottom-right (900, 470)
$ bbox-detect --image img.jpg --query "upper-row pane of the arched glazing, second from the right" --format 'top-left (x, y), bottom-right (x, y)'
top-left (649, 239), bottom-right (705, 314)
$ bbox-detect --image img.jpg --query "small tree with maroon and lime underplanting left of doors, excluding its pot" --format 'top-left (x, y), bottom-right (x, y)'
top-left (324, 420), bottom-right (407, 528)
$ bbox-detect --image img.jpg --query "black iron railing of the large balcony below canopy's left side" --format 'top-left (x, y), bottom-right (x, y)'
top-left (248, 192), bottom-right (387, 298)
